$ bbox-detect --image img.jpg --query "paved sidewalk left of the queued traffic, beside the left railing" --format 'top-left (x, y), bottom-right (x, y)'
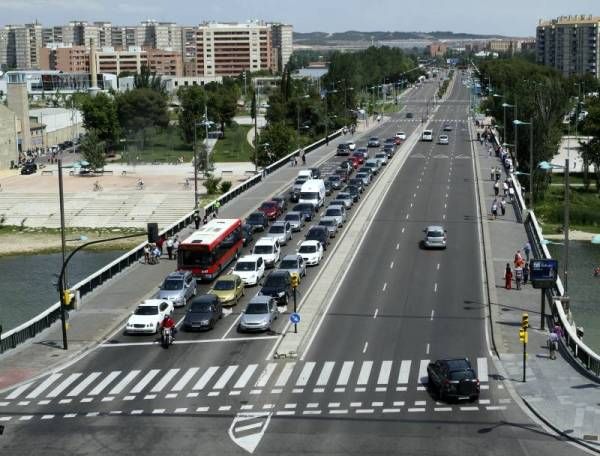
top-left (0, 114), bottom-right (379, 391)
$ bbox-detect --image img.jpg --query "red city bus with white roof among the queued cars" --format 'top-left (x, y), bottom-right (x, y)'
top-left (177, 219), bottom-right (243, 280)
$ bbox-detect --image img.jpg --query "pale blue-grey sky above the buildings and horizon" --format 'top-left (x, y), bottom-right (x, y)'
top-left (0, 0), bottom-right (600, 36)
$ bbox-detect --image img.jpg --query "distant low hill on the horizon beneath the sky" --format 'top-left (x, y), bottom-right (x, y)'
top-left (294, 30), bottom-right (505, 45)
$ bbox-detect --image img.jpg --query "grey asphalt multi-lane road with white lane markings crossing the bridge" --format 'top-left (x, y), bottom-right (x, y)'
top-left (0, 73), bottom-right (576, 455)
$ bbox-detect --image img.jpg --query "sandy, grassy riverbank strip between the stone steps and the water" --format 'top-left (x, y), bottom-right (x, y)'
top-left (0, 226), bottom-right (145, 257)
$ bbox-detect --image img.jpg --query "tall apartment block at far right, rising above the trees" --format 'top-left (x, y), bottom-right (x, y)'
top-left (536, 15), bottom-right (600, 78)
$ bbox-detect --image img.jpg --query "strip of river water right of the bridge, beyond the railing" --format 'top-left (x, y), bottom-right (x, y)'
top-left (548, 241), bottom-right (600, 353)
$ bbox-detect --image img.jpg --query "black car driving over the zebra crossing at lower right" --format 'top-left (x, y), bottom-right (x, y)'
top-left (427, 358), bottom-right (479, 401)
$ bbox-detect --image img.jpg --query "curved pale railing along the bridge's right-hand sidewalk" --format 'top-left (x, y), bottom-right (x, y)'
top-left (493, 128), bottom-right (600, 380)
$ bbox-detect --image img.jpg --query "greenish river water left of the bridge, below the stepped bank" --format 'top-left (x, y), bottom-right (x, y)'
top-left (0, 251), bottom-right (124, 332)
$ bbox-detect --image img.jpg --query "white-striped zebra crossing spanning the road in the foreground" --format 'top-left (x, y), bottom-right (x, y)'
top-left (0, 357), bottom-right (494, 410)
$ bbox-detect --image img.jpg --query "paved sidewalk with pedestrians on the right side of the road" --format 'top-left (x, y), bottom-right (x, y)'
top-left (471, 128), bottom-right (600, 451)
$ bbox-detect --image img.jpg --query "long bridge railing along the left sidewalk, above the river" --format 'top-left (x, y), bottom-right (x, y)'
top-left (0, 129), bottom-right (342, 353)
